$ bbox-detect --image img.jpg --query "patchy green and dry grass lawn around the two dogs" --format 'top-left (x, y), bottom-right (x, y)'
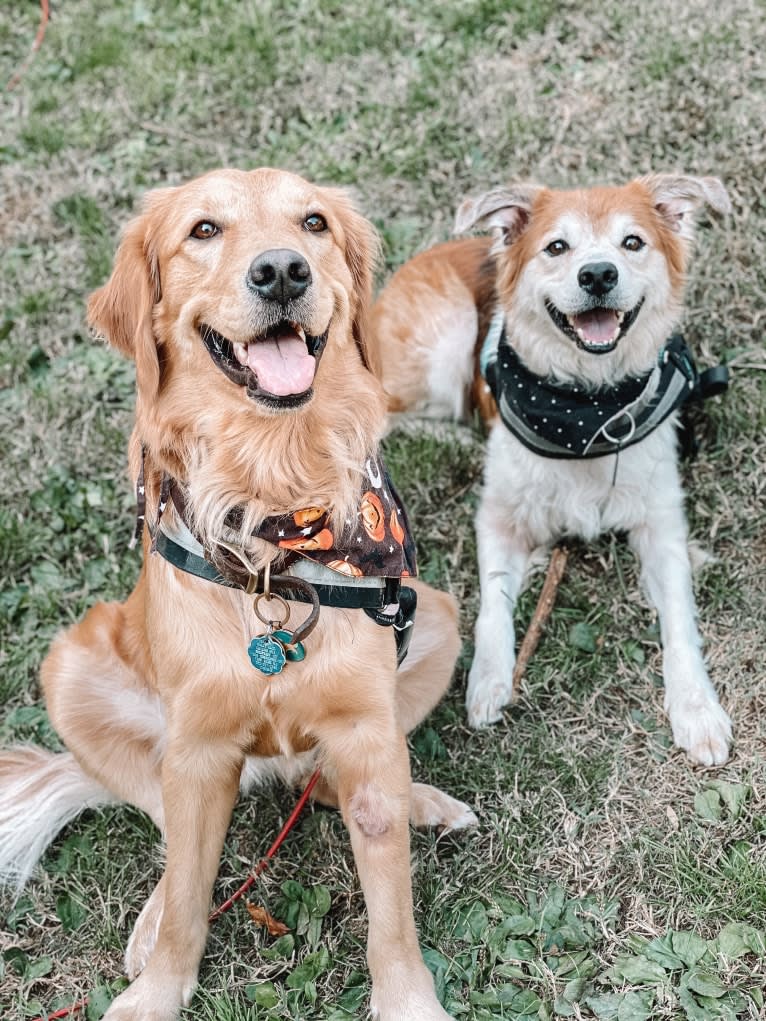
top-left (0, 0), bottom-right (766, 1021)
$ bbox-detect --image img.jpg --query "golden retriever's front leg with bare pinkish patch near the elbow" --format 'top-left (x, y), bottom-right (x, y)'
top-left (322, 718), bottom-right (448, 1021)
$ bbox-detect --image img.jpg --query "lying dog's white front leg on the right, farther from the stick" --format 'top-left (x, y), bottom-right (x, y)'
top-left (630, 494), bottom-right (731, 766)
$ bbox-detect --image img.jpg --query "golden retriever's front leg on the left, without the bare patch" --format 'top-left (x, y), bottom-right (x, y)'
top-left (104, 734), bottom-right (242, 1021)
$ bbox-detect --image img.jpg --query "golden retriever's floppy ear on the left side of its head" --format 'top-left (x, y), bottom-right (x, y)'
top-left (88, 201), bottom-right (160, 397)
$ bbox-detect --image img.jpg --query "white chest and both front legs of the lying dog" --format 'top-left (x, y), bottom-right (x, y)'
top-left (466, 406), bottom-right (731, 766)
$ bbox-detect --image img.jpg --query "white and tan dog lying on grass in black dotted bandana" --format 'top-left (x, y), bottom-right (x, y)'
top-left (373, 175), bottom-right (731, 765)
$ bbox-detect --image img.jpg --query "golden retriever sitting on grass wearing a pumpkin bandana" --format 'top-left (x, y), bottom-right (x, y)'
top-left (0, 168), bottom-right (475, 1021)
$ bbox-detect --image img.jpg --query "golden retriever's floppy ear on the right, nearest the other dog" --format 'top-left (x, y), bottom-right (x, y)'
top-left (323, 188), bottom-right (381, 379)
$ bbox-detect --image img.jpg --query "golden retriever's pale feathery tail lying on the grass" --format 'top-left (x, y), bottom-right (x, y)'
top-left (0, 745), bottom-right (114, 893)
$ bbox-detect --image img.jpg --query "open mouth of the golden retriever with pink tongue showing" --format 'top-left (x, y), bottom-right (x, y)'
top-left (199, 320), bottom-right (329, 407)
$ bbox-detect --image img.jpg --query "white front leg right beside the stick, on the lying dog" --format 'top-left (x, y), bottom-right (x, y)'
top-left (466, 495), bottom-right (531, 727)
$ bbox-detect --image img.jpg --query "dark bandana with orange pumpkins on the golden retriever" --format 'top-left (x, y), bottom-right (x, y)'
top-left (218, 456), bottom-right (418, 578)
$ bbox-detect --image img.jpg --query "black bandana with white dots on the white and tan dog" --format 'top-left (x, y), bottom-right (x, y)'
top-left (484, 329), bottom-right (699, 458)
